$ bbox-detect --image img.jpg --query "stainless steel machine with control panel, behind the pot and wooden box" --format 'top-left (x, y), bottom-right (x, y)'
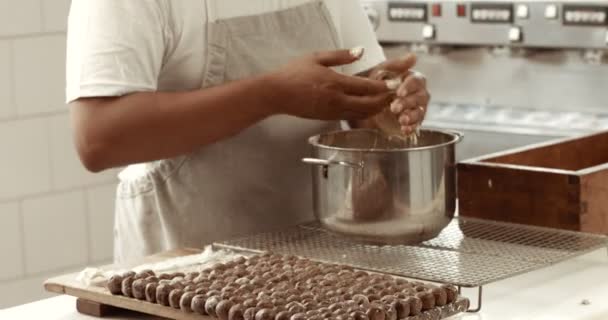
top-left (362, 0), bottom-right (608, 160)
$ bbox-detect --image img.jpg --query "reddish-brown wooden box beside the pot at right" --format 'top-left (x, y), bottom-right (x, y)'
top-left (458, 132), bottom-right (608, 234)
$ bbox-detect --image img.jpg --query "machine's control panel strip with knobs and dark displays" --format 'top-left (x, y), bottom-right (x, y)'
top-left (360, 0), bottom-right (608, 51)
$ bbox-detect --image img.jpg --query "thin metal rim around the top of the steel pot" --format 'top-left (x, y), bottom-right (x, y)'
top-left (308, 128), bottom-right (464, 153)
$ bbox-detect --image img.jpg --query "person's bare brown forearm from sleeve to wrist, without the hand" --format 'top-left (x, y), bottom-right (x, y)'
top-left (72, 73), bottom-right (275, 171)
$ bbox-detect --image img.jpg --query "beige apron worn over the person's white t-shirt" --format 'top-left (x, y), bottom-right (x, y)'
top-left (114, 0), bottom-right (339, 262)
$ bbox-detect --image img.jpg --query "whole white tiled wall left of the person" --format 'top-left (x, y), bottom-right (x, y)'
top-left (0, 0), bottom-right (116, 309)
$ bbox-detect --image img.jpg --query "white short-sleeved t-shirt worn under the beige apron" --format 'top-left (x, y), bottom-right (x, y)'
top-left (66, 0), bottom-right (385, 102)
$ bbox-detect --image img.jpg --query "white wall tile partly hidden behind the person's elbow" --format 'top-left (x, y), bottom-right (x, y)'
top-left (49, 114), bottom-right (117, 189)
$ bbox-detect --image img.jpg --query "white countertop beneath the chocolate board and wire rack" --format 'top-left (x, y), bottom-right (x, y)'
top-left (0, 250), bottom-right (608, 320)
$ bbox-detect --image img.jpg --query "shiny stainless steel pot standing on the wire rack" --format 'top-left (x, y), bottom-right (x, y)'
top-left (302, 129), bottom-right (462, 244)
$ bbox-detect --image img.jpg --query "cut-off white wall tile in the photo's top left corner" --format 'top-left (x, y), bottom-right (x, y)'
top-left (0, 0), bottom-right (42, 36)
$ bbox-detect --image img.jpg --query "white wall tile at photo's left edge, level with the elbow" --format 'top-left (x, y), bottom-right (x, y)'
top-left (0, 119), bottom-right (51, 200)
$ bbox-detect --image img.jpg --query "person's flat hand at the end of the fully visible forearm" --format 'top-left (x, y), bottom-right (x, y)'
top-left (270, 49), bottom-right (394, 120)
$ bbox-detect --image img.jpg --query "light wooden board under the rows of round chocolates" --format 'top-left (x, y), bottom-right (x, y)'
top-left (44, 249), bottom-right (216, 320)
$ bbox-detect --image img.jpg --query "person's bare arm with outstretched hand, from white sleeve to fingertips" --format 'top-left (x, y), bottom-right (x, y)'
top-left (70, 51), bottom-right (389, 172)
